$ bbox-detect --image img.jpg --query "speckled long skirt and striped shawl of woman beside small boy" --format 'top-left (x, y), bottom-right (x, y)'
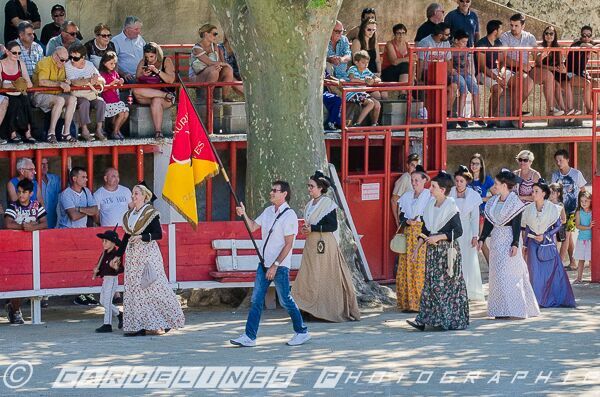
top-left (123, 205), bottom-right (185, 332)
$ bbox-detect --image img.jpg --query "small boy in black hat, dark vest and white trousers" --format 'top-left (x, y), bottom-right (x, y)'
top-left (92, 230), bottom-right (123, 333)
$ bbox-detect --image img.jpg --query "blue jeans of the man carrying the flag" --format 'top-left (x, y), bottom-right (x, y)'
top-left (246, 265), bottom-right (308, 340)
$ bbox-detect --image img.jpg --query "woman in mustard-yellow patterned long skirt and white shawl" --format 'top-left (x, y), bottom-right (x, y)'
top-left (396, 165), bottom-right (431, 313)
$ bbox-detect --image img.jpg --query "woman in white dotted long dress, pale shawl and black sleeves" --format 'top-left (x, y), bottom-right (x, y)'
top-left (479, 170), bottom-right (540, 319)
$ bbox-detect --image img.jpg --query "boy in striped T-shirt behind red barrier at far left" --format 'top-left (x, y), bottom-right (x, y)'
top-left (4, 179), bottom-right (48, 324)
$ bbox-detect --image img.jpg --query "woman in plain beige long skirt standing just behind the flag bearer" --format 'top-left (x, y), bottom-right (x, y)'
top-left (292, 171), bottom-right (360, 322)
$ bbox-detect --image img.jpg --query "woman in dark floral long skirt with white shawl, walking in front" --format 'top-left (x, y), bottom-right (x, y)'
top-left (406, 171), bottom-right (469, 331)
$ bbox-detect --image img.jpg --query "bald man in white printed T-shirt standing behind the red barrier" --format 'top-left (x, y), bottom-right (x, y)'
top-left (94, 167), bottom-right (131, 227)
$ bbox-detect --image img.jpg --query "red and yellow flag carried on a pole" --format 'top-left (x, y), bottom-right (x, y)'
top-left (162, 89), bottom-right (219, 228)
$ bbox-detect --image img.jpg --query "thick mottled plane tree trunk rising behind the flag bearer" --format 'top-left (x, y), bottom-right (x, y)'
top-left (212, 0), bottom-right (388, 302)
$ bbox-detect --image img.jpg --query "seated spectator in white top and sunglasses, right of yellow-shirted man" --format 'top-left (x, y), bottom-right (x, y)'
top-left (65, 43), bottom-right (106, 142)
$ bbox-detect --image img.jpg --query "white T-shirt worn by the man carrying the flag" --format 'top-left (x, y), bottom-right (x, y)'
top-left (255, 203), bottom-right (298, 269)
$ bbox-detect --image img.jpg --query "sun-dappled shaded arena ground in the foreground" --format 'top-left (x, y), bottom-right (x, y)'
top-left (0, 268), bottom-right (600, 396)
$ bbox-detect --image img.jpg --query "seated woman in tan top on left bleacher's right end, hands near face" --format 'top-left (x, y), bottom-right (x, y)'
top-left (132, 42), bottom-right (175, 139)
